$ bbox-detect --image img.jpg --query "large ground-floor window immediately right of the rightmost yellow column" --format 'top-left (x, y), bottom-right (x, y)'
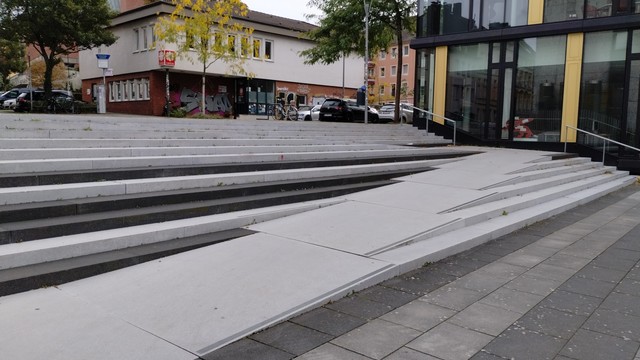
top-left (578, 31), bottom-right (627, 140)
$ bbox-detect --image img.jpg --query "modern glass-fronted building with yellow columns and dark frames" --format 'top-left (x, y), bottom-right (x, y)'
top-left (411, 0), bottom-right (640, 147)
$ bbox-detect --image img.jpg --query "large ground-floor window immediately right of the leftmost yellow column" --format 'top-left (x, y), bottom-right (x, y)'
top-left (445, 44), bottom-right (489, 137)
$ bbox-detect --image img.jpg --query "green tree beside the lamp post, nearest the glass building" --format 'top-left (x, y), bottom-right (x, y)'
top-left (302, 0), bottom-right (416, 121)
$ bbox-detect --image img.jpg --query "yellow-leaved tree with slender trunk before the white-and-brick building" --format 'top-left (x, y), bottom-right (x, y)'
top-left (155, 0), bottom-right (253, 114)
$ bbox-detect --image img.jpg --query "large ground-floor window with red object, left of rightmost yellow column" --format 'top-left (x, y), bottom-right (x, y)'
top-left (513, 35), bottom-right (567, 141)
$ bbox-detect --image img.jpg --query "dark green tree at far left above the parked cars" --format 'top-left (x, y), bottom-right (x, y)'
top-left (0, 0), bottom-right (117, 96)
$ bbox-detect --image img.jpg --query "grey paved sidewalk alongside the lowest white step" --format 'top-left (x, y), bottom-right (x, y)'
top-left (209, 185), bottom-right (640, 360)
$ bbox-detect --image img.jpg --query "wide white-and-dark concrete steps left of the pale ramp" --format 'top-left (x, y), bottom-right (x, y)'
top-left (0, 115), bottom-right (462, 295)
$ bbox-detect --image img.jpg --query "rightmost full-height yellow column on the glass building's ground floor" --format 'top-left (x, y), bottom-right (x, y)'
top-left (560, 33), bottom-right (584, 142)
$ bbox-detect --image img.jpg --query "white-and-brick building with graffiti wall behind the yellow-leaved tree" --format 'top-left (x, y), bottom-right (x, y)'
top-left (80, 0), bottom-right (364, 115)
